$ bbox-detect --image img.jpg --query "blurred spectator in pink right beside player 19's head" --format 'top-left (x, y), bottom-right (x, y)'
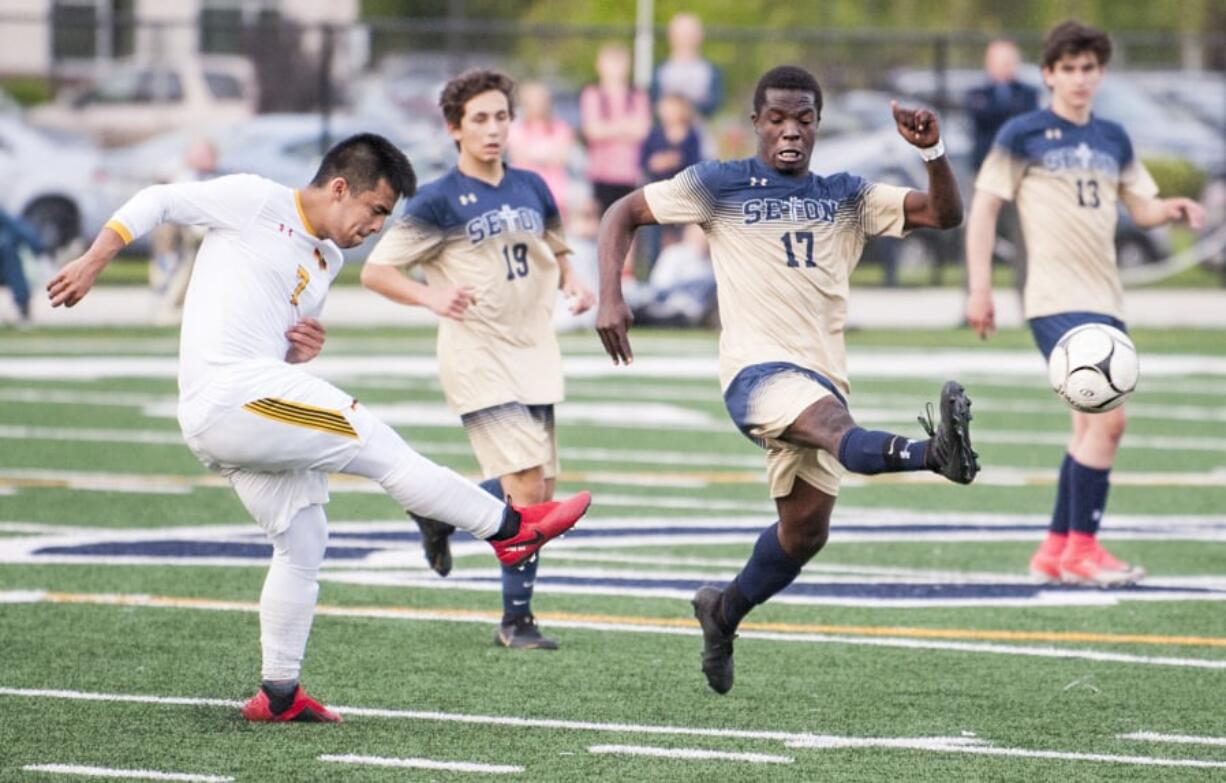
top-left (506, 82), bottom-right (575, 217)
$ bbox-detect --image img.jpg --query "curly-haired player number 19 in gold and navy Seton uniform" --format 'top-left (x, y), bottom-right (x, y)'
top-left (362, 70), bottom-right (596, 649)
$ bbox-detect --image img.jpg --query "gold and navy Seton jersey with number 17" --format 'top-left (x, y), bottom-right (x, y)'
top-left (644, 158), bottom-right (907, 395)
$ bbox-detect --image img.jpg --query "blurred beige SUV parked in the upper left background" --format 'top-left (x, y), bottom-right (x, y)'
top-left (28, 55), bottom-right (256, 146)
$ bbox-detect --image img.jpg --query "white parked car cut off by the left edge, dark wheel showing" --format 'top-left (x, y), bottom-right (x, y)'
top-left (0, 114), bottom-right (105, 249)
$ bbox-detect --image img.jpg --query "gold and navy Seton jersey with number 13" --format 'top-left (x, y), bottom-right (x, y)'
top-left (975, 109), bottom-right (1157, 319)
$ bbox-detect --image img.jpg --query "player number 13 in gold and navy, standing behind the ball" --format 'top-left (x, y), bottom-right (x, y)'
top-left (966, 21), bottom-right (1204, 586)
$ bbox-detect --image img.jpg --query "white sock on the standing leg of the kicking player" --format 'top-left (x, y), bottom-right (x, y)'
top-left (260, 506), bottom-right (327, 681)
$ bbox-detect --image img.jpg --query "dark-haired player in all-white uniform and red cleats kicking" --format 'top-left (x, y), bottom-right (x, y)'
top-left (47, 134), bottom-right (590, 722)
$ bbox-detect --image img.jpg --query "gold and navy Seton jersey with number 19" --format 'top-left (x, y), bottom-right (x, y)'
top-left (367, 168), bottom-right (569, 414)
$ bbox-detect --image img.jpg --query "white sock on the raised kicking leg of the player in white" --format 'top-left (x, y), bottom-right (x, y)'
top-left (342, 422), bottom-right (506, 538)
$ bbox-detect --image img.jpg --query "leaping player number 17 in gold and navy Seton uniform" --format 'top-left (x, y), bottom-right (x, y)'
top-left (596, 66), bottom-right (978, 694)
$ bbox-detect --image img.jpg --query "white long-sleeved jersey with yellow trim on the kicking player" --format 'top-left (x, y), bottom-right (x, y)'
top-left (107, 174), bottom-right (345, 436)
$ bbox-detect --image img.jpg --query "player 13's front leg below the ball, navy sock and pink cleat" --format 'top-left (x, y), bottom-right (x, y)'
top-left (1043, 407), bottom-right (1145, 587)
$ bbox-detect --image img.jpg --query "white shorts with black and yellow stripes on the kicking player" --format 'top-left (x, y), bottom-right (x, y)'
top-left (180, 365), bottom-right (375, 535)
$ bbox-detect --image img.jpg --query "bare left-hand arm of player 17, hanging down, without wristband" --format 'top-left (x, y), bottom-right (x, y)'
top-left (596, 187), bottom-right (657, 364)
